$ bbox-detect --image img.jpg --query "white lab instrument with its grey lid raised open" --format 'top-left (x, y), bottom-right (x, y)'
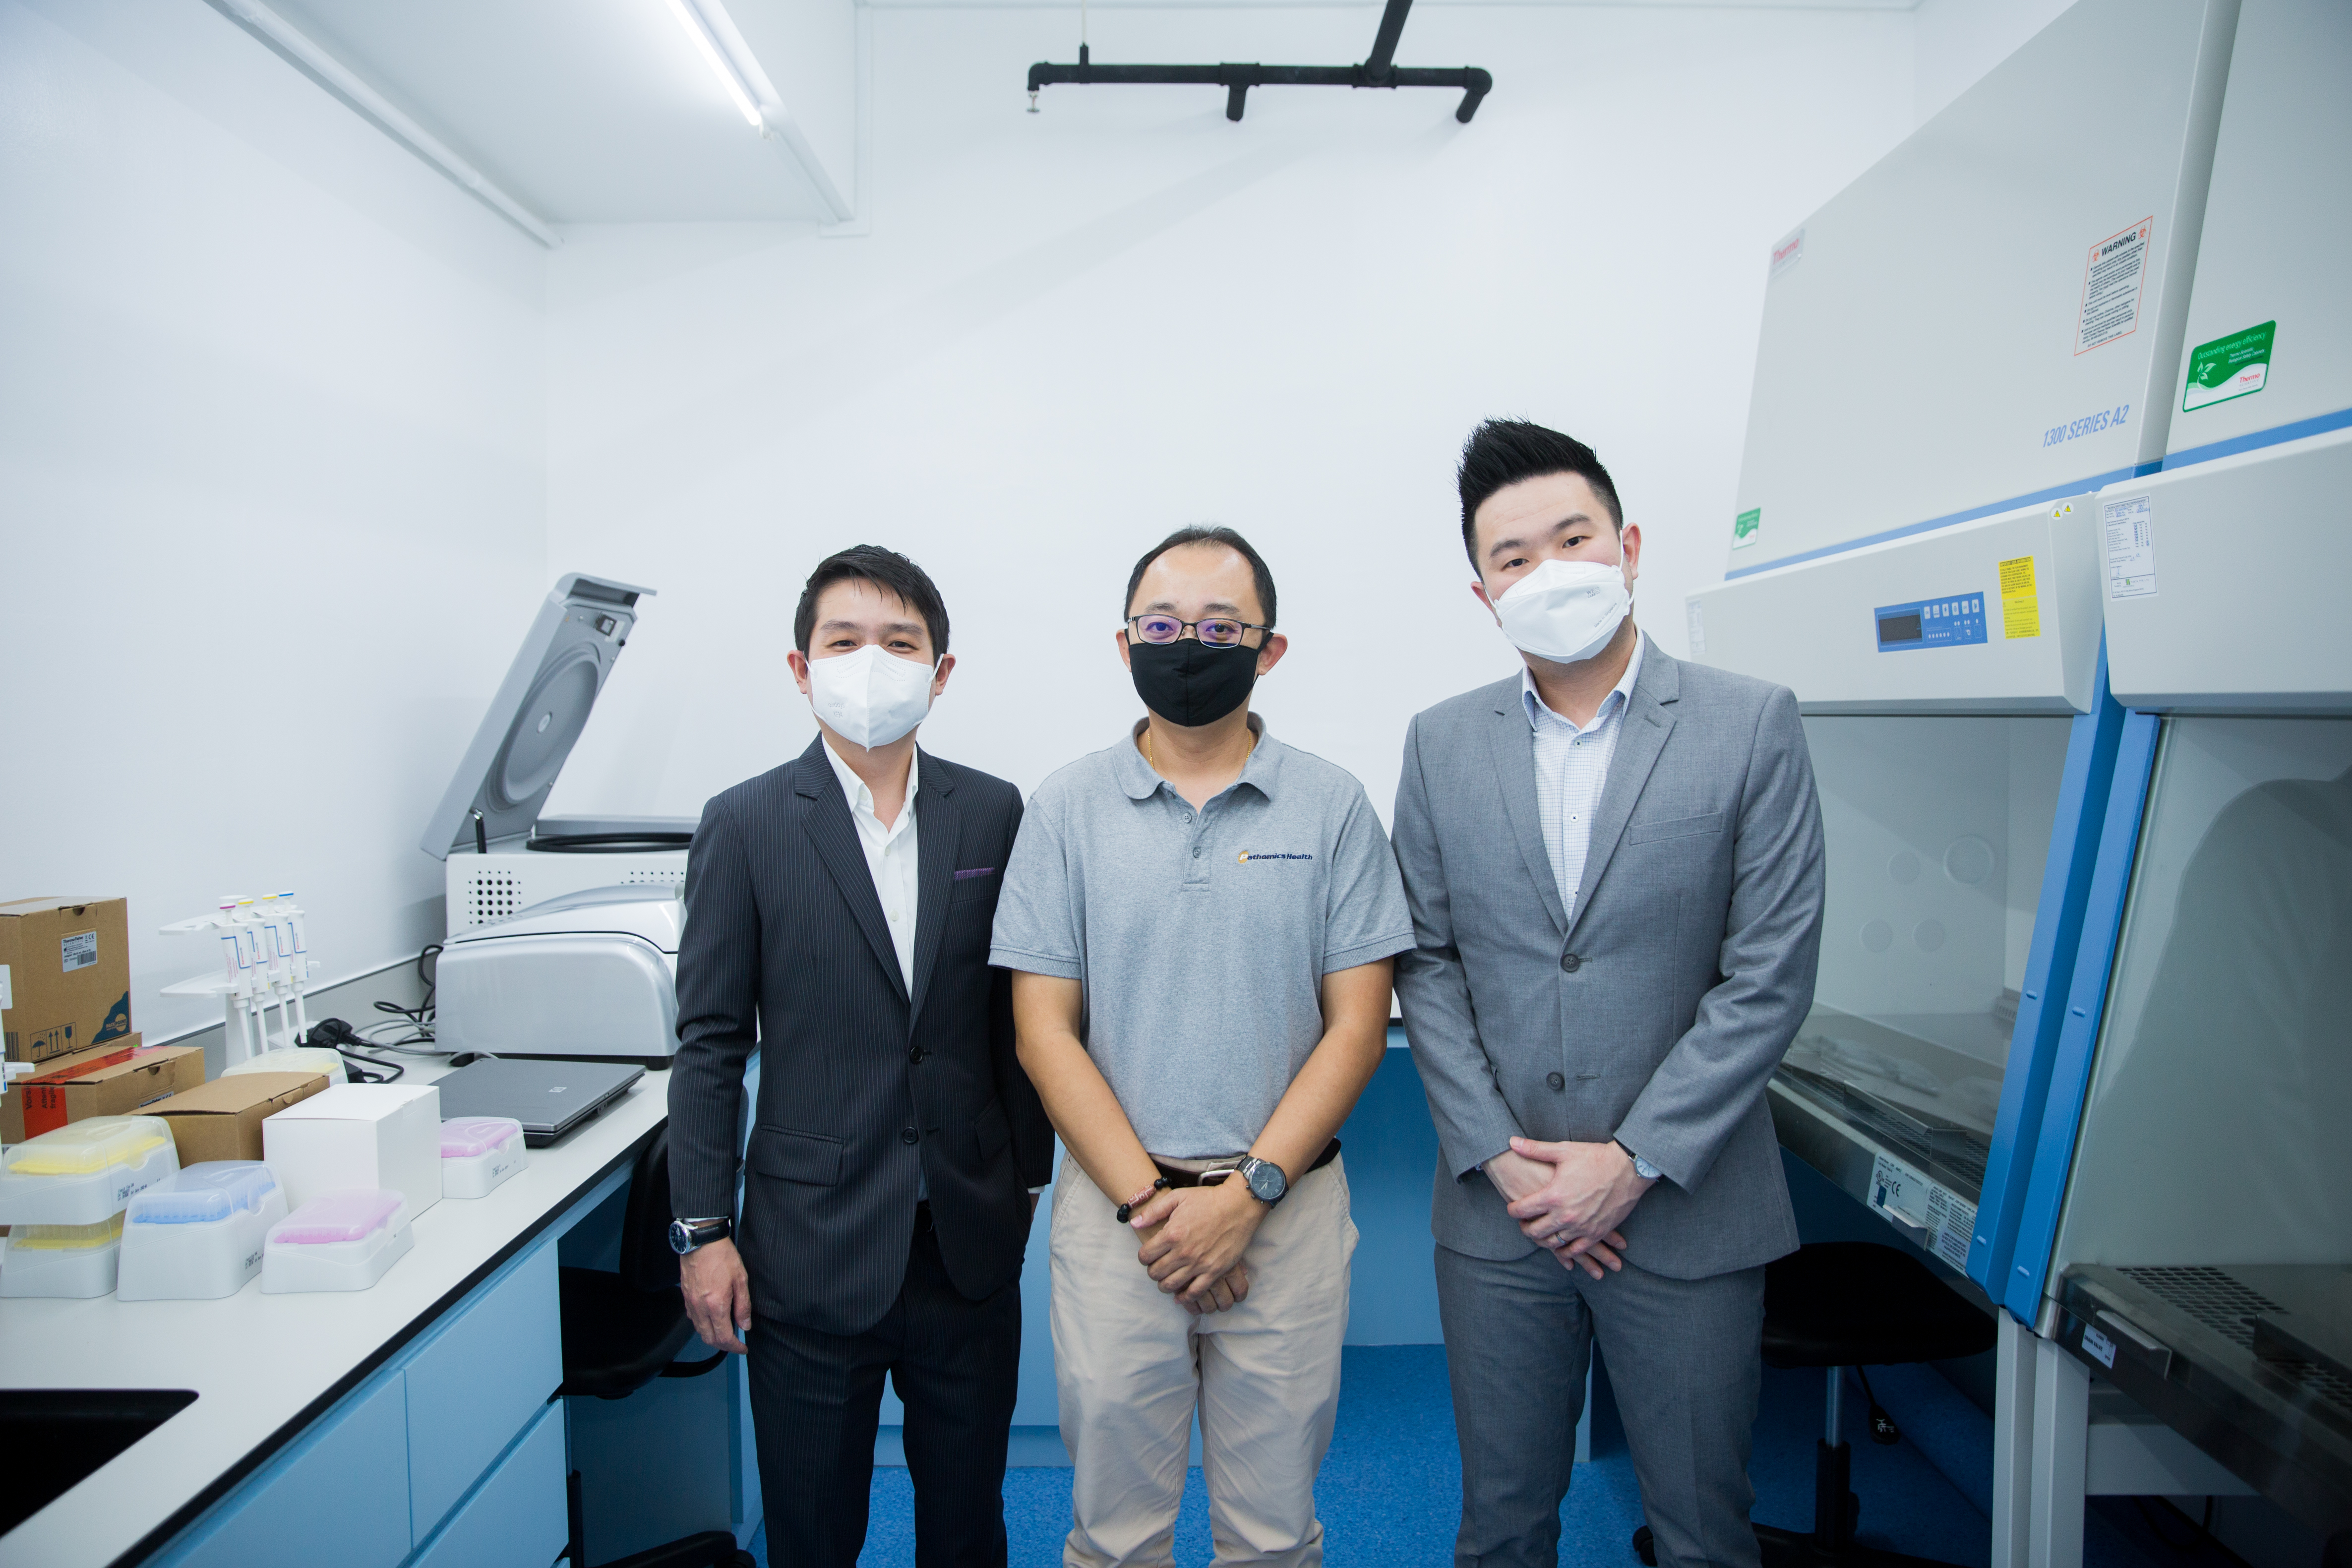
top-left (423, 583), bottom-right (694, 936)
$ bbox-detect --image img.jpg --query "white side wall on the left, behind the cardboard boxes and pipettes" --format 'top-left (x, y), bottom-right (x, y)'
top-left (0, 0), bottom-right (548, 1039)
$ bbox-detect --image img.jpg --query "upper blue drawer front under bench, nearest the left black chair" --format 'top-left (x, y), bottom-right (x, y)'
top-left (409, 1246), bottom-right (564, 1540)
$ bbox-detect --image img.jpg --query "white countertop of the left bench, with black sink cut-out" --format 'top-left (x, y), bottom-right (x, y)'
top-left (0, 1058), bottom-right (670, 1568)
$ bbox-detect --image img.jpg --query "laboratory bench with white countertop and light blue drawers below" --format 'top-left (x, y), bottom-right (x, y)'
top-left (0, 1058), bottom-right (738, 1568)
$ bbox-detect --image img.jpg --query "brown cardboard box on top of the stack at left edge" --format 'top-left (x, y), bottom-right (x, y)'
top-left (0, 898), bottom-right (132, 1063)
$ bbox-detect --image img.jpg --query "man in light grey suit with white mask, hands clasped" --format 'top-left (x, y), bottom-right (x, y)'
top-left (1395, 421), bottom-right (1820, 1568)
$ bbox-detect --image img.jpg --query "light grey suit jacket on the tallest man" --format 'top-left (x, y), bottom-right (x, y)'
top-left (1395, 642), bottom-right (1820, 1279)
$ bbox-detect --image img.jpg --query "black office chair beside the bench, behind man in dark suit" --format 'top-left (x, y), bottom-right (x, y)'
top-left (555, 1121), bottom-right (753, 1568)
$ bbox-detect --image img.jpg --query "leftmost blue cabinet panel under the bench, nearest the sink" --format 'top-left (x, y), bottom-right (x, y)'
top-left (158, 1373), bottom-right (412, 1568)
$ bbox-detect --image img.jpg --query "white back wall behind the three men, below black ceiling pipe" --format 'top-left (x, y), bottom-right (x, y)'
top-left (548, 7), bottom-right (1912, 813)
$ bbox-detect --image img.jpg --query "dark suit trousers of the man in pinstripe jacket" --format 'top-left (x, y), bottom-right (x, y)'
top-left (748, 1204), bottom-right (1021, 1568)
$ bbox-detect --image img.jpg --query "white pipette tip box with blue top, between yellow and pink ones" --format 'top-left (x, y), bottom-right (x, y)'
top-left (115, 1159), bottom-right (287, 1302)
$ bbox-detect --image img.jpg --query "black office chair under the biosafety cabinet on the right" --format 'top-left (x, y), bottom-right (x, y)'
top-left (1632, 1241), bottom-right (1994, 1568)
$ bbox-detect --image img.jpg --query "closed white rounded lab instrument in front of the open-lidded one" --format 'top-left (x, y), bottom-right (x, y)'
top-left (433, 886), bottom-right (687, 1067)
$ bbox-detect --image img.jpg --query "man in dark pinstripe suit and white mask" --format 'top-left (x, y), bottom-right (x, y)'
top-left (670, 545), bottom-right (1054, 1568)
